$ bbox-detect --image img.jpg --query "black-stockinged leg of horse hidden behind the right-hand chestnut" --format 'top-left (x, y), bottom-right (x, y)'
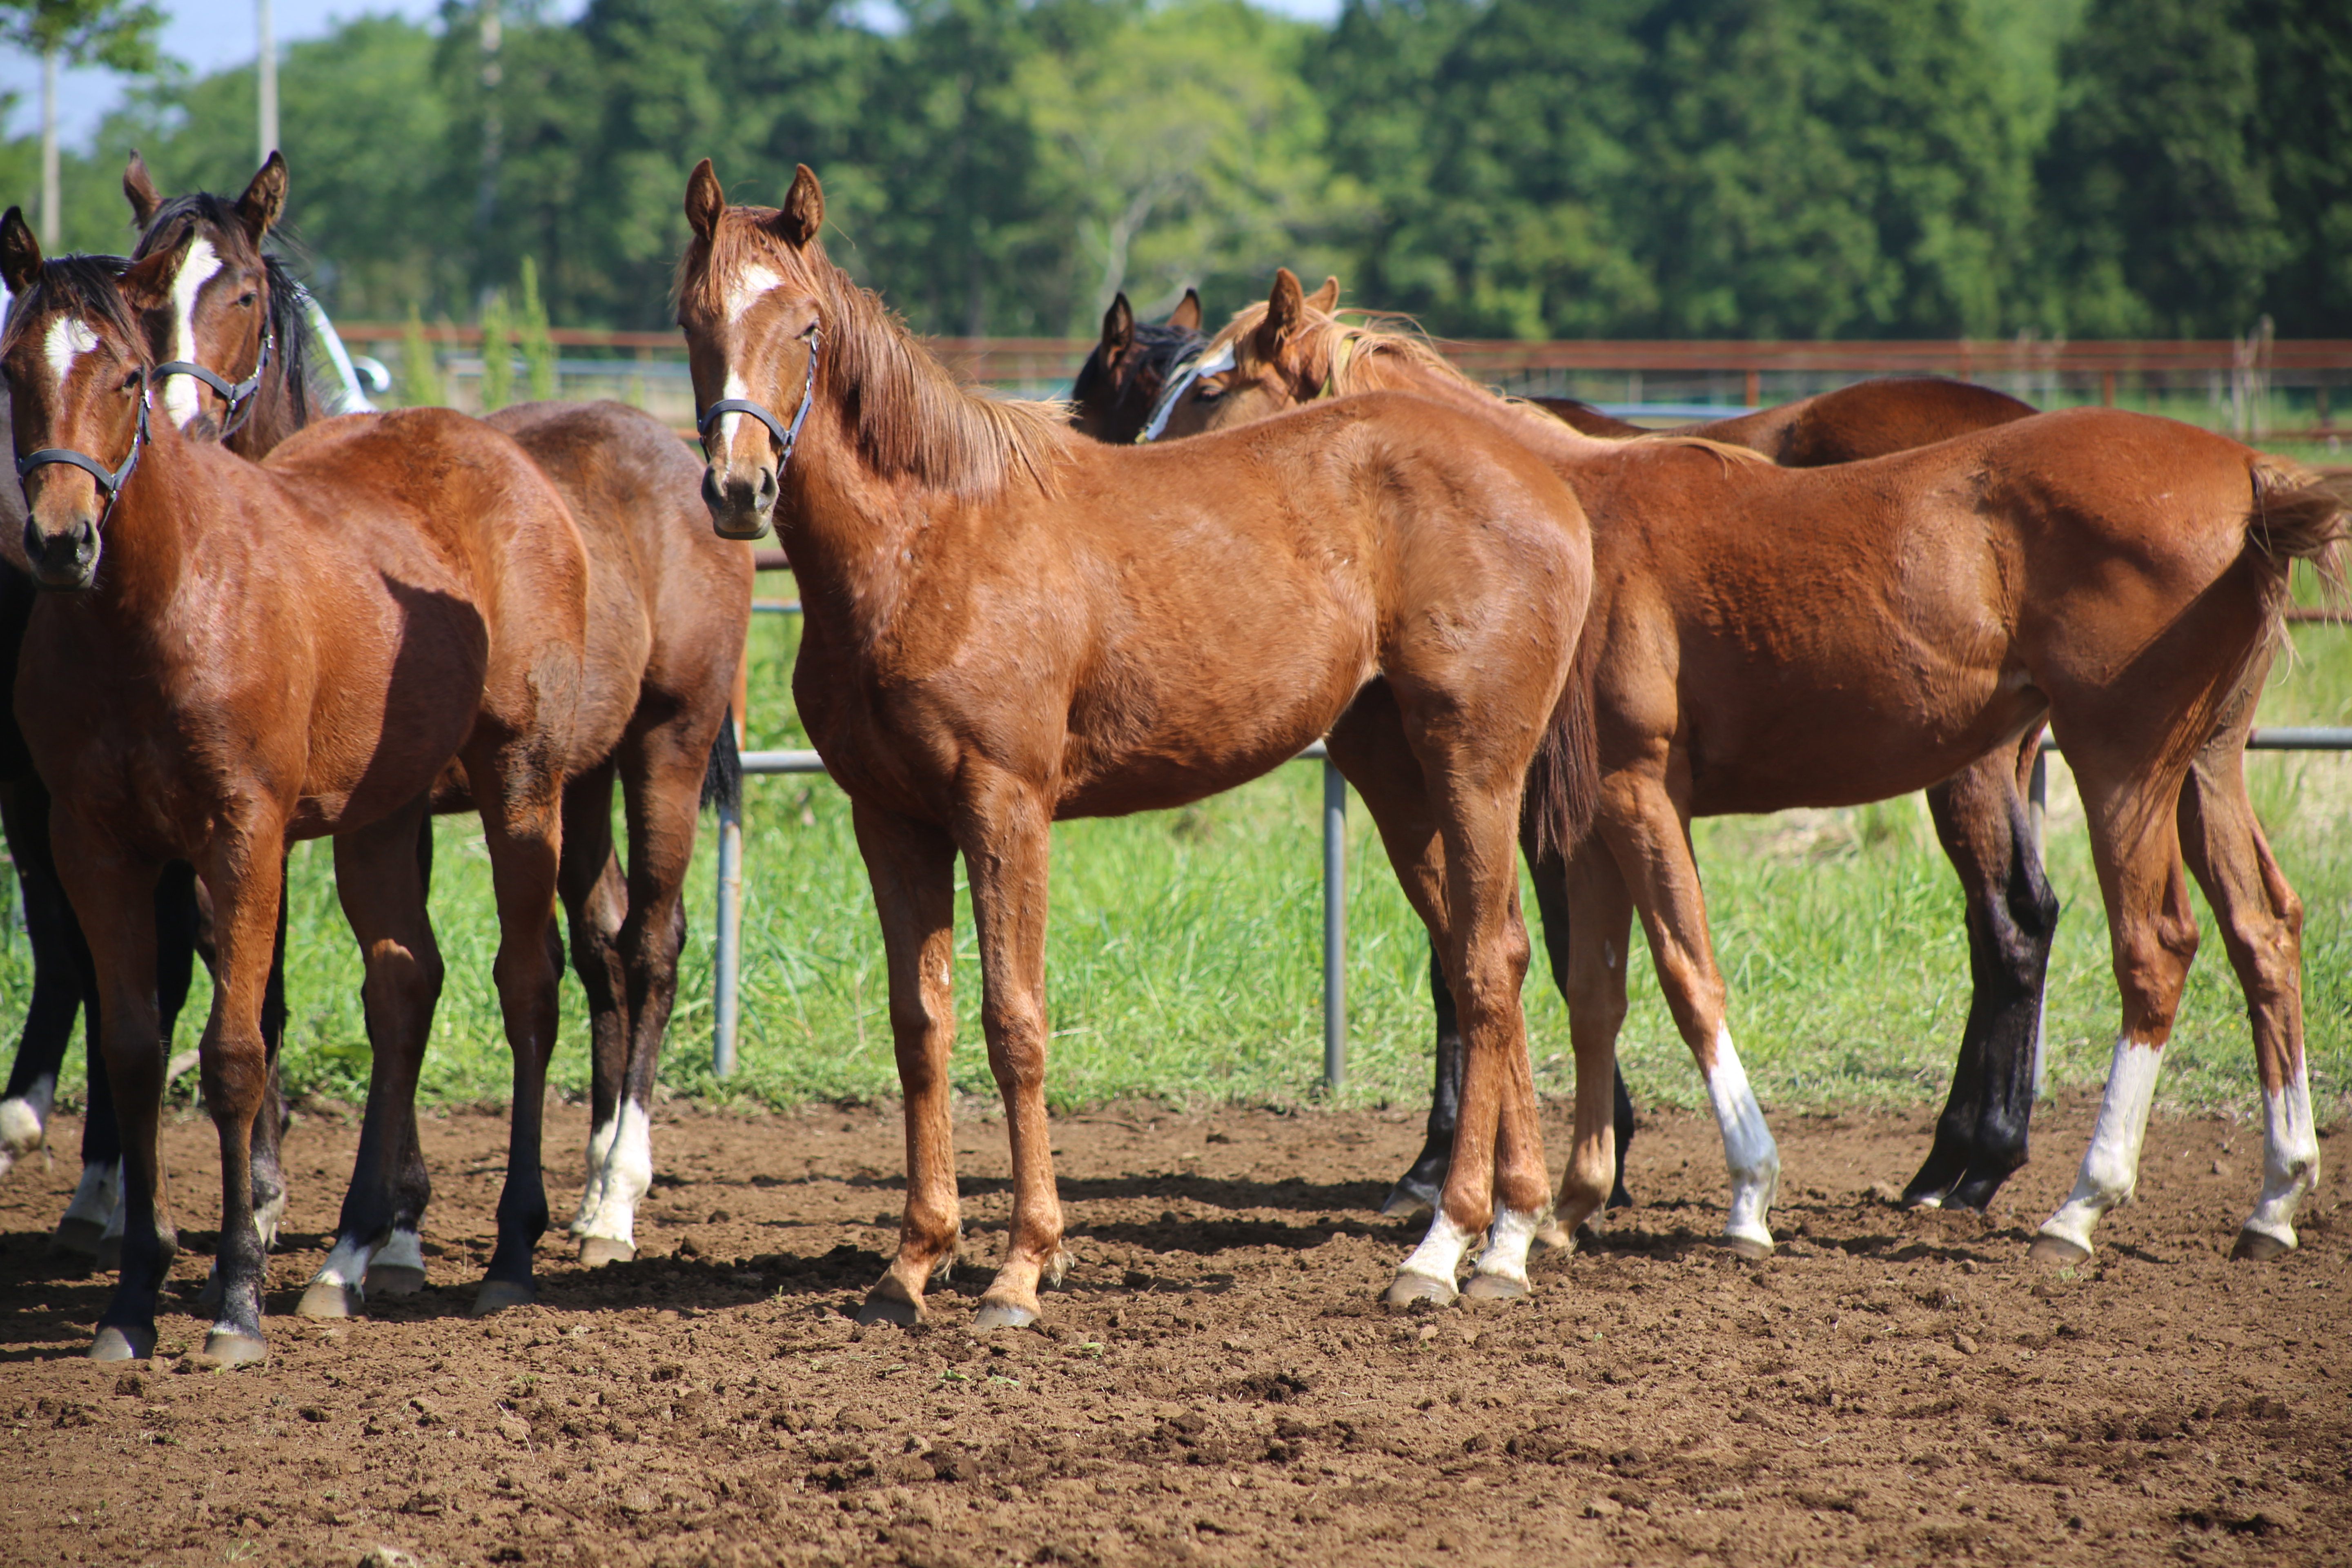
top-left (1903, 740), bottom-right (2058, 1211)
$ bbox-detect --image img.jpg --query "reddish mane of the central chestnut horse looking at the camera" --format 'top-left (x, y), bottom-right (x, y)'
top-left (677, 217), bottom-right (1068, 501)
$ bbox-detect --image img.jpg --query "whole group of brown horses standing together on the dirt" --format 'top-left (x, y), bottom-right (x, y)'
top-left (0, 155), bottom-right (2343, 1361)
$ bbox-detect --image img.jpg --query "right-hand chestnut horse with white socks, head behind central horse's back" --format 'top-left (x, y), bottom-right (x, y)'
top-left (1164, 273), bottom-right (2343, 1260)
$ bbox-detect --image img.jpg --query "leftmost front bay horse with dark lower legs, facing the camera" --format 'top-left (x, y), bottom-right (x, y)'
top-left (0, 207), bottom-right (588, 1361)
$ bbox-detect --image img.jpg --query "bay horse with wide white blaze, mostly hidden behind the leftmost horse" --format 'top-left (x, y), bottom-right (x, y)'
top-left (110, 153), bottom-right (753, 1316)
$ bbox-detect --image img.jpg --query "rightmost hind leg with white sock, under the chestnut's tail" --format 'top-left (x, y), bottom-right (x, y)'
top-left (2180, 736), bottom-right (2319, 1263)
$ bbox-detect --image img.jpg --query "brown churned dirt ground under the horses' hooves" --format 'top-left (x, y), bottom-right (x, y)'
top-left (0, 1100), bottom-right (2352, 1568)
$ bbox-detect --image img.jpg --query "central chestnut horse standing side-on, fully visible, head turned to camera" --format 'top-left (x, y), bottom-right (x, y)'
top-left (677, 160), bottom-right (1590, 1331)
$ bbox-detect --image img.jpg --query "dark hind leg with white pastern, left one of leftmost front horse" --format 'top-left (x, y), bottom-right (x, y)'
top-left (296, 797), bottom-right (442, 1316)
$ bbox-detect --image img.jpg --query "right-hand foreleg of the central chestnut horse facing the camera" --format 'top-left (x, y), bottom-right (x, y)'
top-left (955, 780), bottom-right (1065, 1333)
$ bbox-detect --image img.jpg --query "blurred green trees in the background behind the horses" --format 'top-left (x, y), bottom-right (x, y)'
top-left (0, 0), bottom-right (2352, 339)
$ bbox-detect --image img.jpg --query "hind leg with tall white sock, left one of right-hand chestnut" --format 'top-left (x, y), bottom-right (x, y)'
top-left (2032, 748), bottom-right (2197, 1263)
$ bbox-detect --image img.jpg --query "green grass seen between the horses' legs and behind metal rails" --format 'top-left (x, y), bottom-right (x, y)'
top-left (0, 578), bottom-right (2352, 1133)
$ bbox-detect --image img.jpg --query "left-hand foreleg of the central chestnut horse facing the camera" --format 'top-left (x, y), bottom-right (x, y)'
top-left (851, 802), bottom-right (962, 1323)
